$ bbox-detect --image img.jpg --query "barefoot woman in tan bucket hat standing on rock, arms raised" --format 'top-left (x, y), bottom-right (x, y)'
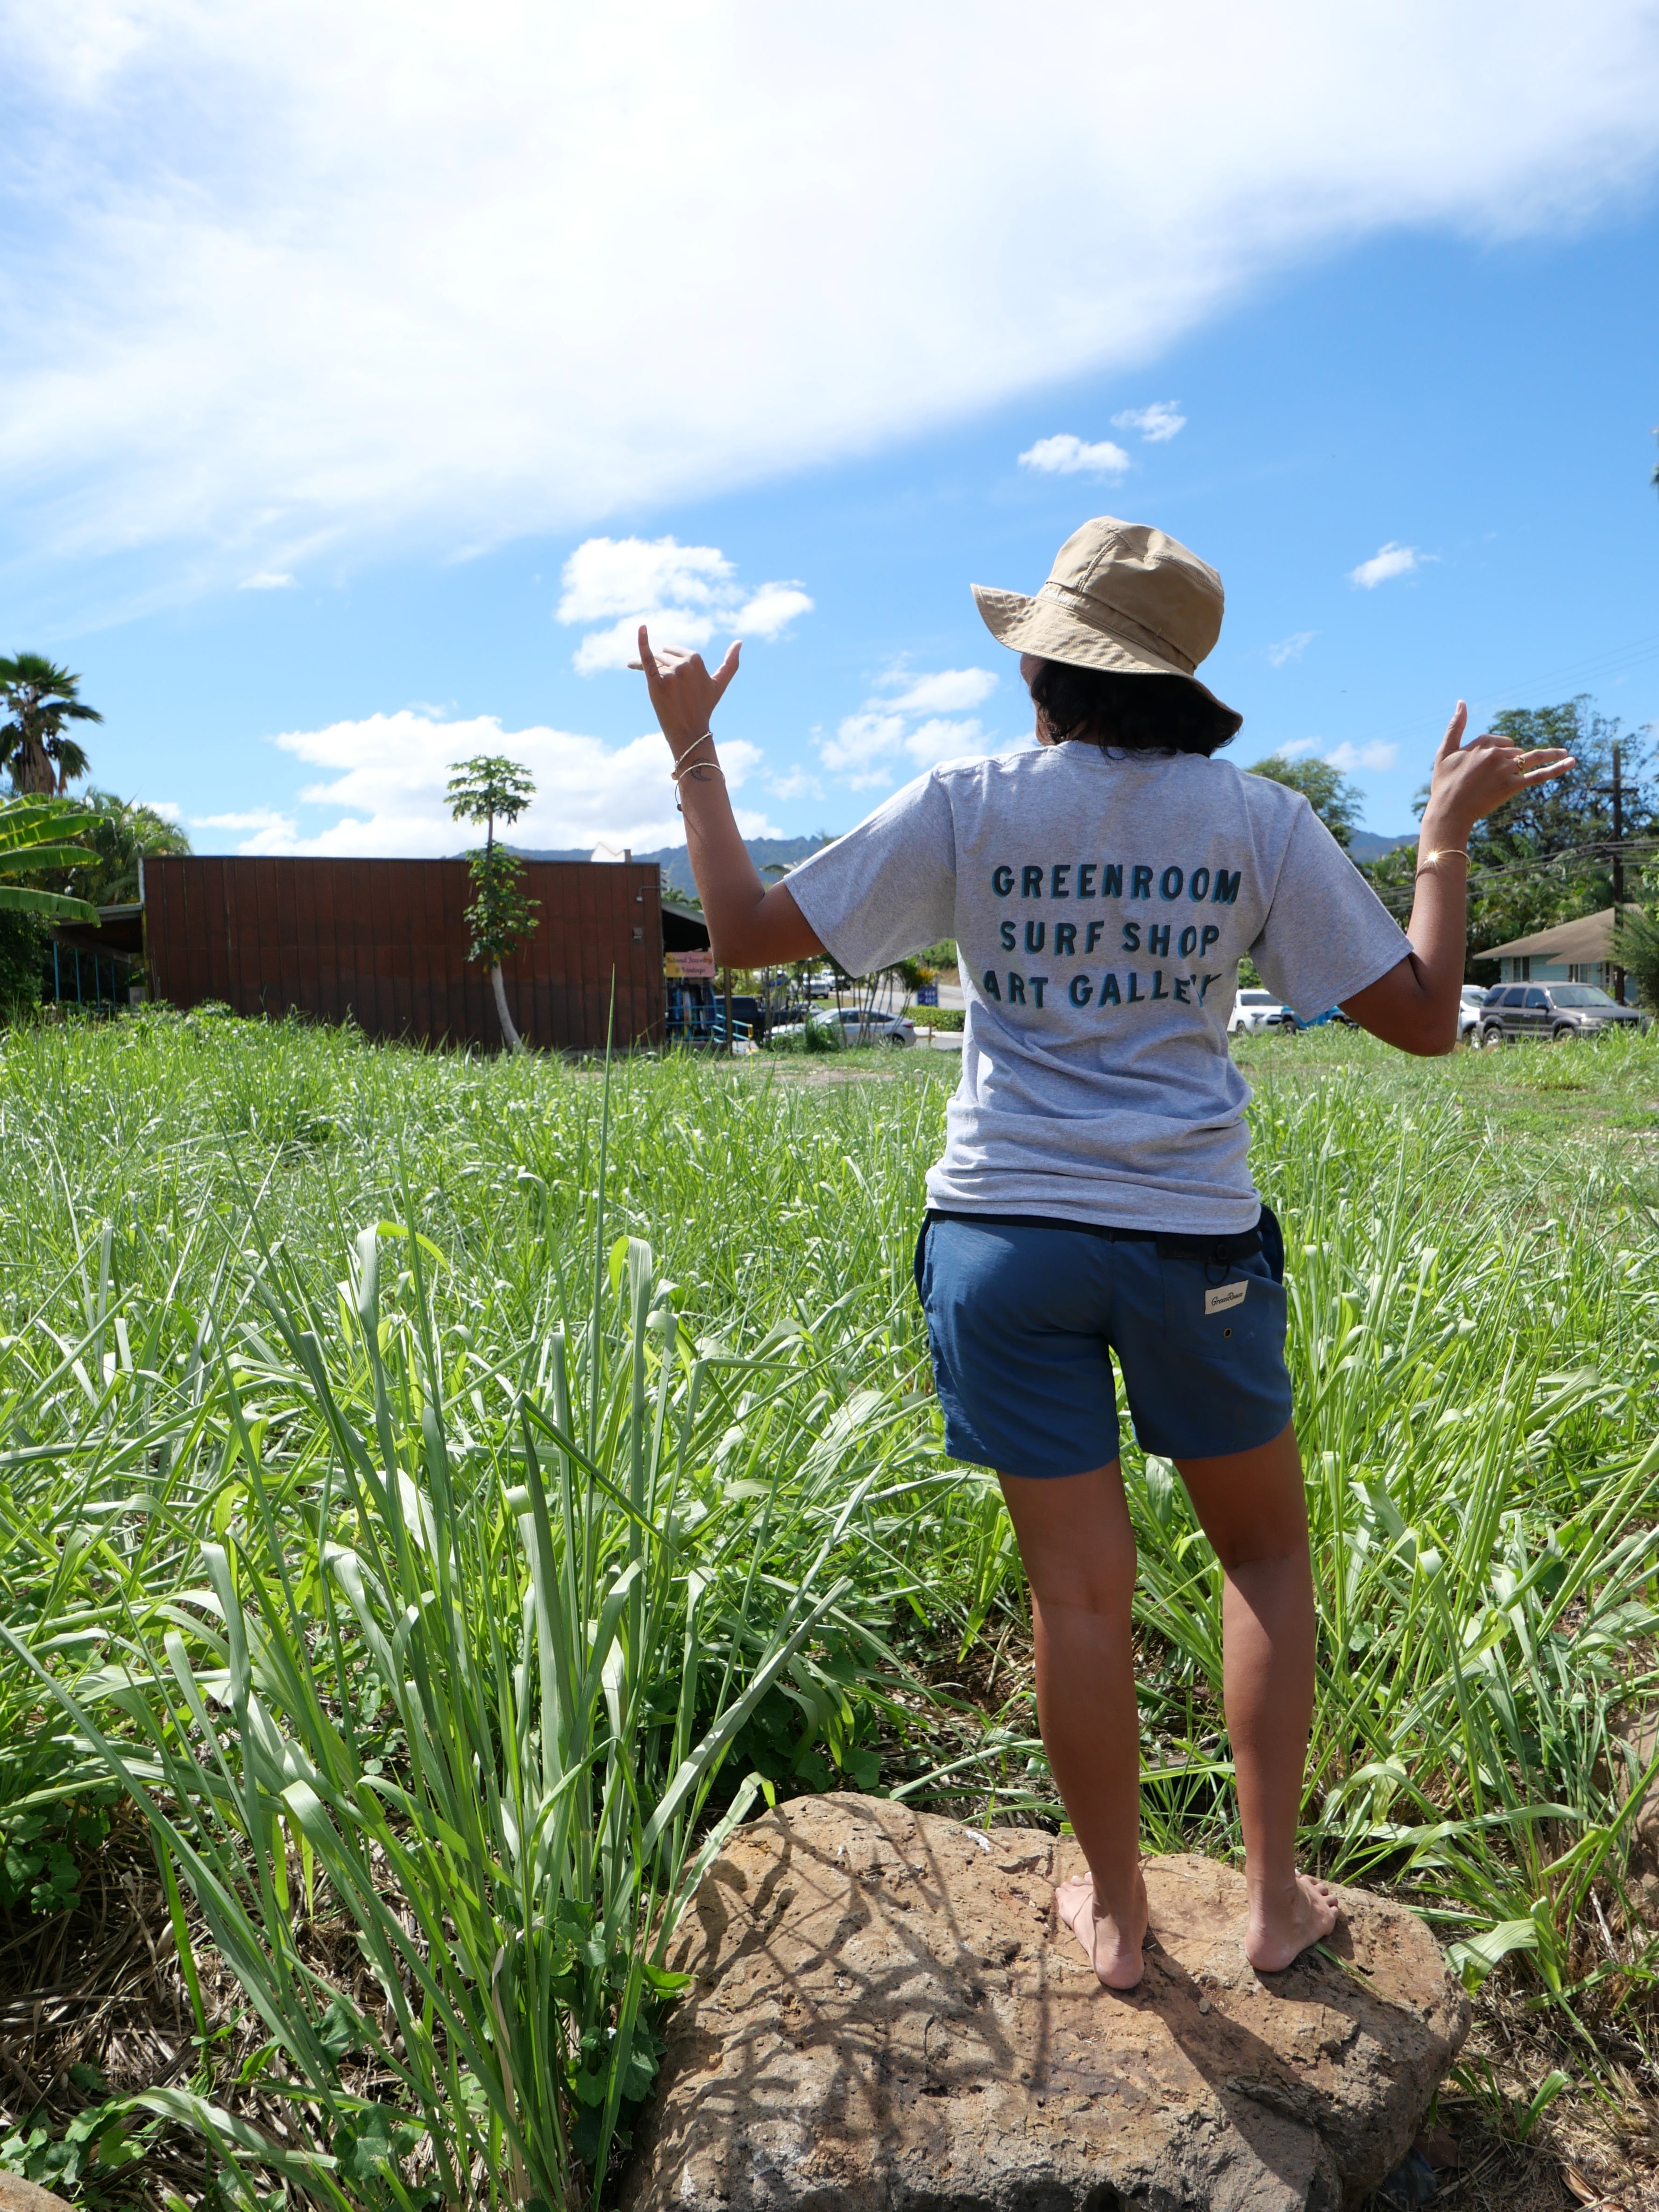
top-left (639, 518), bottom-right (1571, 1989)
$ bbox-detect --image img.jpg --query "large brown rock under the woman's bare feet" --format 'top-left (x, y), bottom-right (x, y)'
top-left (624, 1796), bottom-right (1467, 2212)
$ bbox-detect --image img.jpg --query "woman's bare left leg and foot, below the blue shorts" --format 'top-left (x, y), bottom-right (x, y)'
top-left (1000, 1460), bottom-right (1146, 1989)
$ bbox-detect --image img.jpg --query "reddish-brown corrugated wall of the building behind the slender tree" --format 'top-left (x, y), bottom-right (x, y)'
top-left (144, 856), bottom-right (664, 1051)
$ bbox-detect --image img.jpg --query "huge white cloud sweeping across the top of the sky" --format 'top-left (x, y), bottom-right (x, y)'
top-left (0, 0), bottom-right (1659, 606)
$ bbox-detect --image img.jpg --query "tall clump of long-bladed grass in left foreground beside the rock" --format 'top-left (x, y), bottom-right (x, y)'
top-left (13, 1226), bottom-right (955, 2205)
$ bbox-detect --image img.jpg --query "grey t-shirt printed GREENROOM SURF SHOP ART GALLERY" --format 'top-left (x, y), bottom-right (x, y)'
top-left (790, 741), bottom-right (1409, 1234)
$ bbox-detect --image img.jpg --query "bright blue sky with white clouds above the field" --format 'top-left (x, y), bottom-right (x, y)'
top-left (0, 0), bottom-right (1659, 851)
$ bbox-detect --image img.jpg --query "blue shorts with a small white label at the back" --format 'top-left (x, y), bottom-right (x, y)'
top-left (916, 1205), bottom-right (1290, 1475)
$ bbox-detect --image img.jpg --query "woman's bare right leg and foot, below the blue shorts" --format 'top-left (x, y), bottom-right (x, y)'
top-left (1175, 1429), bottom-right (1336, 1973)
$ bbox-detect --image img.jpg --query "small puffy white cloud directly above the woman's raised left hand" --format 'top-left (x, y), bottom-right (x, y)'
top-left (557, 538), bottom-right (812, 677)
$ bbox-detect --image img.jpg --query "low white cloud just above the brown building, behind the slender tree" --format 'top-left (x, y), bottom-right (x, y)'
top-left (199, 708), bottom-right (781, 858)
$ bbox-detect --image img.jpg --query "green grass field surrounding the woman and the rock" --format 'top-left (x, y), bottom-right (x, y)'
top-left (0, 1015), bottom-right (1659, 2208)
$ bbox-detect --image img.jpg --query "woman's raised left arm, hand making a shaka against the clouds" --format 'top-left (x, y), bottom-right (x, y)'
top-left (635, 622), bottom-right (823, 967)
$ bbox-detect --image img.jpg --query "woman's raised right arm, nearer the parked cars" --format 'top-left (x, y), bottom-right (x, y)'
top-left (1343, 699), bottom-right (1573, 1057)
